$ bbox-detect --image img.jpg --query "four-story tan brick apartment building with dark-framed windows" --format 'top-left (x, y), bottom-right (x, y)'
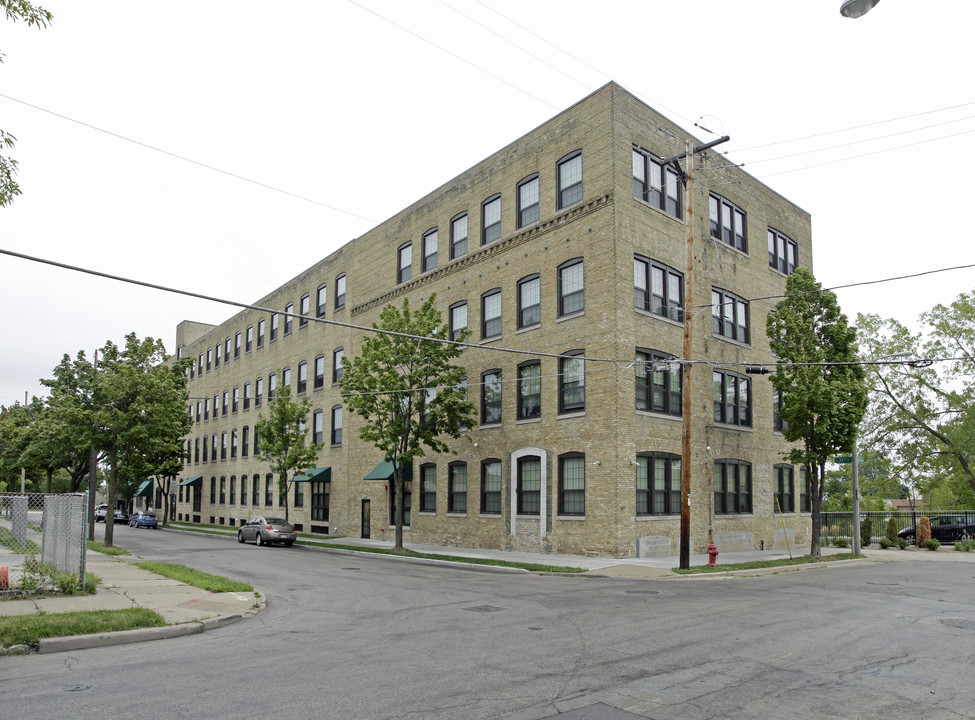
top-left (177, 83), bottom-right (812, 556)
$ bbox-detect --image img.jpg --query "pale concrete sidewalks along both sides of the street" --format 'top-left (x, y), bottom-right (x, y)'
top-left (0, 528), bottom-right (975, 652)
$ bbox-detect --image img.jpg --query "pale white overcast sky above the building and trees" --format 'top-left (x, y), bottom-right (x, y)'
top-left (0, 0), bottom-right (975, 404)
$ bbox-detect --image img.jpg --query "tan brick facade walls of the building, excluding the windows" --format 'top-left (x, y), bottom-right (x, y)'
top-left (177, 83), bottom-right (812, 556)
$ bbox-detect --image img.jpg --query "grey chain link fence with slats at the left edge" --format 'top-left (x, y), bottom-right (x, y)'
top-left (0, 493), bottom-right (88, 594)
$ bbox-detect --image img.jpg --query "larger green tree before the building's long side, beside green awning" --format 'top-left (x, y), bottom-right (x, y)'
top-left (339, 295), bottom-right (476, 549)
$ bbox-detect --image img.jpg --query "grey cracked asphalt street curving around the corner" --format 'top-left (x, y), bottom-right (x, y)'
top-left (0, 532), bottom-right (975, 720)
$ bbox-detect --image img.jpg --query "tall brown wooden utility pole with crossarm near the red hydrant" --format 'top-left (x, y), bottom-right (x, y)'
top-left (660, 135), bottom-right (731, 570)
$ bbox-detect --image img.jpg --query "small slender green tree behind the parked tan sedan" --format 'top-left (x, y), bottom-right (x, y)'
top-left (254, 385), bottom-right (322, 520)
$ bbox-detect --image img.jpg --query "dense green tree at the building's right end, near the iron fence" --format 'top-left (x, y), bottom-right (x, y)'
top-left (767, 268), bottom-right (867, 555)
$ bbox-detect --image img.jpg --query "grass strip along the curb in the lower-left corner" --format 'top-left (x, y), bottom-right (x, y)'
top-left (0, 608), bottom-right (166, 647)
